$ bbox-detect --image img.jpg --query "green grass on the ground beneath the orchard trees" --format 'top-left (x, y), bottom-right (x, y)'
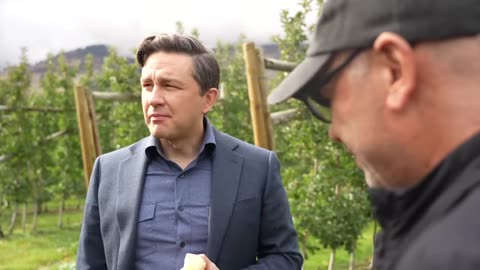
top-left (0, 201), bottom-right (373, 270)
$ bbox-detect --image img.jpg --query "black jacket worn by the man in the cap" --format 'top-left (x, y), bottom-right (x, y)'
top-left (371, 134), bottom-right (480, 270)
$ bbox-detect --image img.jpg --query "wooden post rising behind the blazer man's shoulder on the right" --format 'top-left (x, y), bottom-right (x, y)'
top-left (243, 42), bottom-right (273, 150)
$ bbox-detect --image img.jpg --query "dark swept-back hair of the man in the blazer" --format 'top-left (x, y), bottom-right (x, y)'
top-left (137, 34), bottom-right (220, 95)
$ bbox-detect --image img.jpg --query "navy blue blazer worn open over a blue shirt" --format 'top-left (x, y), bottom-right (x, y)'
top-left (77, 129), bottom-right (303, 270)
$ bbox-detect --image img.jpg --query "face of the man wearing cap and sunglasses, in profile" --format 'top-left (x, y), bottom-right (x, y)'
top-left (322, 52), bottom-right (394, 187)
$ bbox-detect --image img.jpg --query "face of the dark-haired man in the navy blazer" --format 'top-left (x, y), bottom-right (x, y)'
top-left (140, 52), bottom-right (213, 140)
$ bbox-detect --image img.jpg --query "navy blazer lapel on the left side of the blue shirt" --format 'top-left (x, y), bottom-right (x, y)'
top-left (117, 148), bottom-right (147, 269)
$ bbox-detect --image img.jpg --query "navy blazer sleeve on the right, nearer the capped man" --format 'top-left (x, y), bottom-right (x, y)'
top-left (246, 152), bottom-right (303, 270)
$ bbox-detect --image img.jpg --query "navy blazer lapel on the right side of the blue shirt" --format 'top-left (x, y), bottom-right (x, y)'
top-left (207, 130), bottom-right (243, 261)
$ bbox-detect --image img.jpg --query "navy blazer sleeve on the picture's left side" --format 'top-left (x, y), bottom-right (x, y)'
top-left (76, 157), bottom-right (107, 270)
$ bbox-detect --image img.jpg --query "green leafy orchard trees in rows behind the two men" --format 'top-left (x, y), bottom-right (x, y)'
top-left (0, 0), bottom-right (370, 266)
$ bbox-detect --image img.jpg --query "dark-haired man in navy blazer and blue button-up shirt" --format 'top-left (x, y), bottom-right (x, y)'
top-left (77, 34), bottom-right (303, 270)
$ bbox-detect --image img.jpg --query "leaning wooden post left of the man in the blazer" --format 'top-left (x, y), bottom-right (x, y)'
top-left (75, 86), bottom-right (100, 189)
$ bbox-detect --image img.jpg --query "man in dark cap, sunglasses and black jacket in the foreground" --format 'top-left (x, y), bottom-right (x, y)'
top-left (268, 0), bottom-right (480, 270)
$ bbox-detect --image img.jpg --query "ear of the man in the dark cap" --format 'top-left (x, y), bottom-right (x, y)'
top-left (373, 32), bottom-right (416, 110)
